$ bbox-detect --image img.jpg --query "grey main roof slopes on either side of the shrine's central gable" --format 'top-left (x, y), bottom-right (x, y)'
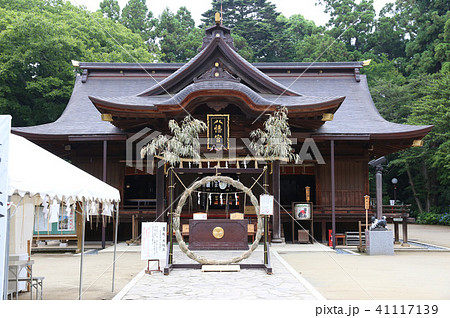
top-left (13, 63), bottom-right (431, 136)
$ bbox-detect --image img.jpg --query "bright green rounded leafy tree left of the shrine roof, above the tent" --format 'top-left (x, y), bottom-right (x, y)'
top-left (0, 0), bottom-right (153, 126)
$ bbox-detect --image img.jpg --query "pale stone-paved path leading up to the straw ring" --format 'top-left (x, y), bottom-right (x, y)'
top-left (114, 246), bottom-right (324, 300)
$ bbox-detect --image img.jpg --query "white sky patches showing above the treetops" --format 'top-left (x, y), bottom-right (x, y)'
top-left (70, 0), bottom-right (394, 25)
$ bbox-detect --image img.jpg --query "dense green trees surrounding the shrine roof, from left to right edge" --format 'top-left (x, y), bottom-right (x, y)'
top-left (0, 0), bottom-right (450, 223)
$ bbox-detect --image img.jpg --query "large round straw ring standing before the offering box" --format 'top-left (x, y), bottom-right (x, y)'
top-left (173, 176), bottom-right (263, 265)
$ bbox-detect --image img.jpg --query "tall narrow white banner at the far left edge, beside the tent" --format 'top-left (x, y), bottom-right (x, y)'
top-left (0, 115), bottom-right (11, 299)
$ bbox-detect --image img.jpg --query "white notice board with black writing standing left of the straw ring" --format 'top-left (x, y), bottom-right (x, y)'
top-left (141, 222), bottom-right (167, 260)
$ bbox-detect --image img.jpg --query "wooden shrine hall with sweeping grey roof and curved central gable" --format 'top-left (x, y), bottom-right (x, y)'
top-left (13, 19), bottom-right (432, 247)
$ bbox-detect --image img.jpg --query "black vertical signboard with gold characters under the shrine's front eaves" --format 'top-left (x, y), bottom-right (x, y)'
top-left (207, 115), bottom-right (230, 150)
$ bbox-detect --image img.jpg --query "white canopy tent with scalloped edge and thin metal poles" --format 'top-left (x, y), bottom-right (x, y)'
top-left (6, 134), bottom-right (120, 299)
